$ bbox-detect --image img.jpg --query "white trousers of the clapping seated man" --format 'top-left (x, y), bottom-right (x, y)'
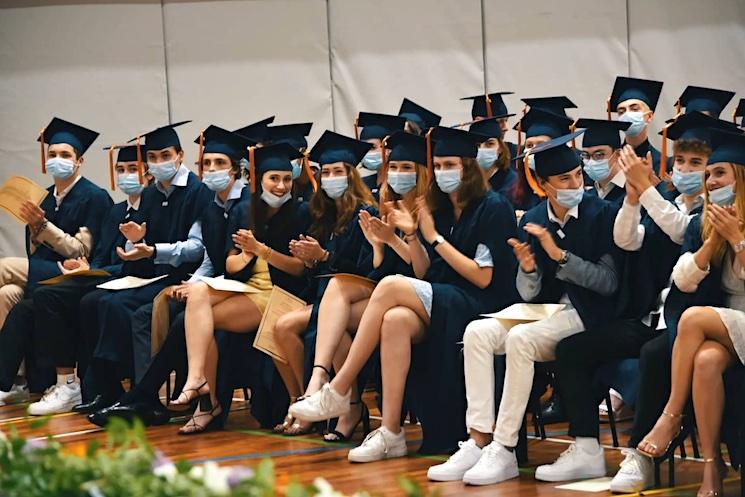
top-left (463, 309), bottom-right (584, 447)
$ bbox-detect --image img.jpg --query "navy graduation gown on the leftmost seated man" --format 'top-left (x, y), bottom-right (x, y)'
top-left (26, 177), bottom-right (113, 292)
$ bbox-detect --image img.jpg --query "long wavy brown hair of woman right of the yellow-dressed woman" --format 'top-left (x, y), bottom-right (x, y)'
top-left (308, 162), bottom-right (377, 239)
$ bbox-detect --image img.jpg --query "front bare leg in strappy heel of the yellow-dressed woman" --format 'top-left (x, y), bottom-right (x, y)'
top-left (173, 283), bottom-right (235, 405)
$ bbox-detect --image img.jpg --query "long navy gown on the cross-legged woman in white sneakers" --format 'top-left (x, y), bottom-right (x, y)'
top-left (407, 191), bottom-right (518, 453)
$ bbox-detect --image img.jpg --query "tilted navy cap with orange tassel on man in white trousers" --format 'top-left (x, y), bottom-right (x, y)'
top-left (516, 130), bottom-right (584, 197)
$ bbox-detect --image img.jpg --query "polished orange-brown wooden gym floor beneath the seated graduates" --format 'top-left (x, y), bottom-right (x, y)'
top-left (0, 391), bottom-right (739, 497)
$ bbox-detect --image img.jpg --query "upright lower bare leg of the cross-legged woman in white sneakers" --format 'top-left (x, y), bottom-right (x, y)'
top-left (380, 306), bottom-right (426, 433)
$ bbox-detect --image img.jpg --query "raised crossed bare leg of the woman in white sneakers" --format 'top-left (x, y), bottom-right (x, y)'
top-left (331, 276), bottom-right (429, 400)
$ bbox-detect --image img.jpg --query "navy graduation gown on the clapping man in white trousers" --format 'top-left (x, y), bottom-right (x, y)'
top-left (520, 193), bottom-right (624, 328)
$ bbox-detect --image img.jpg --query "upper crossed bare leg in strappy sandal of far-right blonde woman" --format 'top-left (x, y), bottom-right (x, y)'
top-left (638, 307), bottom-right (734, 456)
